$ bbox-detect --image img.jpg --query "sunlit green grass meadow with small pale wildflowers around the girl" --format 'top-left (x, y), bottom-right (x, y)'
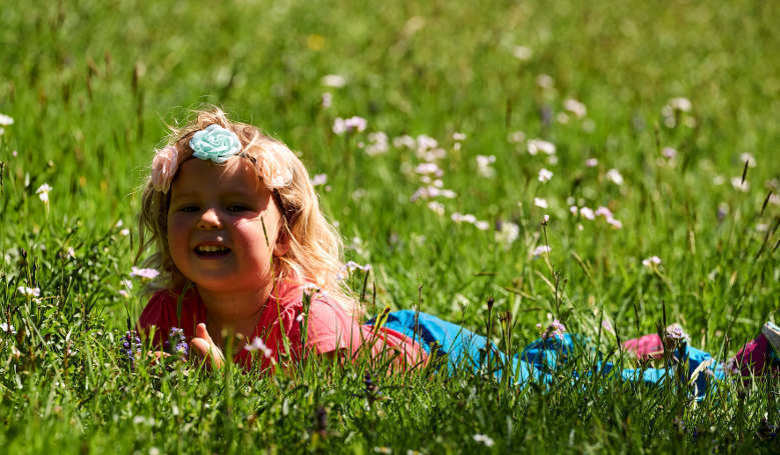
top-left (0, 0), bottom-right (780, 454)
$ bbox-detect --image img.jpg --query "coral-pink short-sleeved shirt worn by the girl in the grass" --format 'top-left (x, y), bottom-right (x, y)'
top-left (138, 282), bottom-right (427, 369)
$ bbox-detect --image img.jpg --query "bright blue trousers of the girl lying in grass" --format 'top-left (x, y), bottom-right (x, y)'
top-left (366, 310), bottom-right (725, 399)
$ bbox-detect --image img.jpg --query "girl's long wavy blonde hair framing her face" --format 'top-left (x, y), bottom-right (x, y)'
top-left (136, 106), bottom-right (361, 315)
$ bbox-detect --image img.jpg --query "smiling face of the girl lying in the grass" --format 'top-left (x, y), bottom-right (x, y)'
top-left (168, 157), bottom-right (287, 292)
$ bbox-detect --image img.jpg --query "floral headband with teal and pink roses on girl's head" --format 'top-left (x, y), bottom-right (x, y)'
top-left (152, 124), bottom-right (241, 193)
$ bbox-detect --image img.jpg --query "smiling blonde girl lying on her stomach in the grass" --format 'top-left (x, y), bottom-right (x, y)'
top-left (139, 108), bottom-right (778, 393)
